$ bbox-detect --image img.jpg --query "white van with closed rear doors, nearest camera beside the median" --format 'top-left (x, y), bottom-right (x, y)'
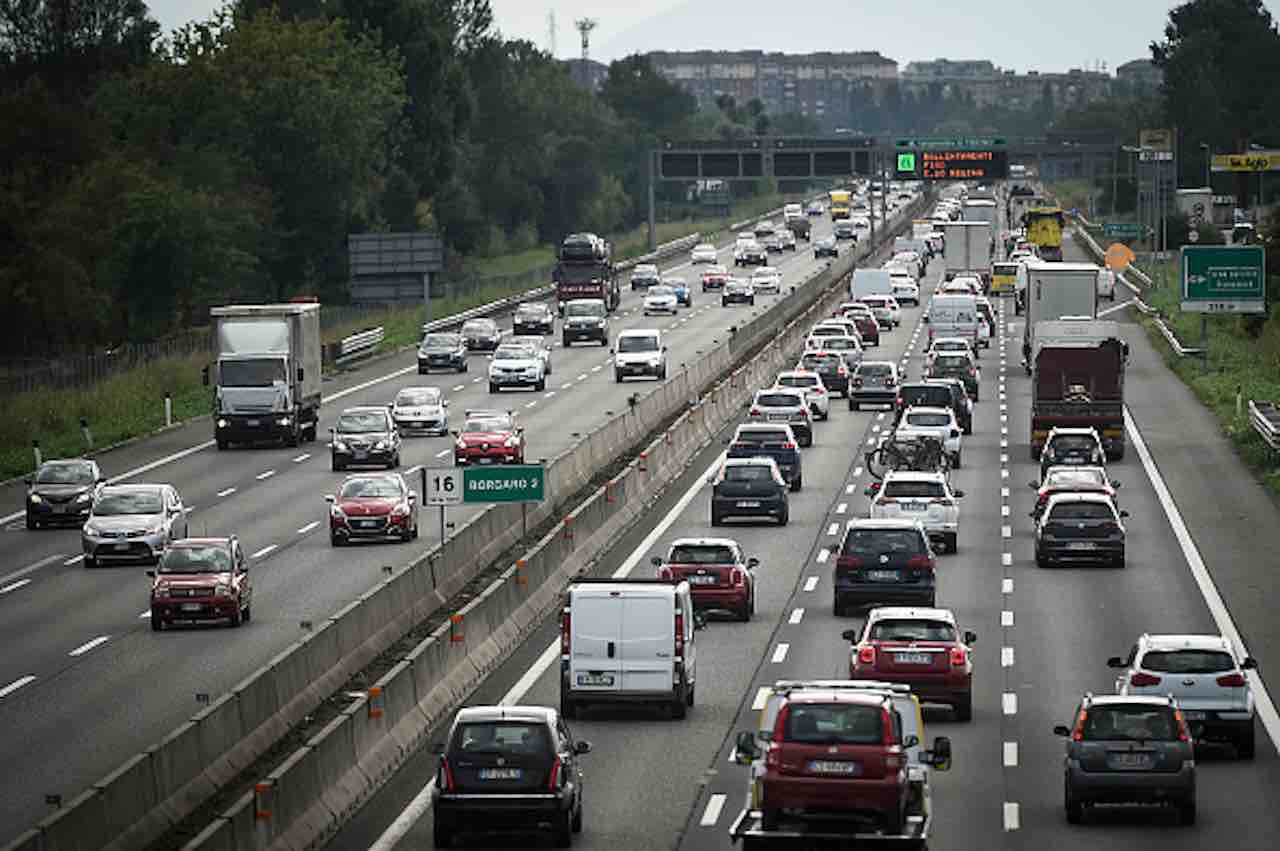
top-left (561, 578), bottom-right (705, 718)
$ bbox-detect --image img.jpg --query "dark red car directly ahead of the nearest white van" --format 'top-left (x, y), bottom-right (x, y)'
top-left (652, 537), bottom-right (760, 621)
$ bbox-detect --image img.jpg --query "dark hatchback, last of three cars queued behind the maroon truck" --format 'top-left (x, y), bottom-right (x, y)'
top-left (1036, 493), bottom-right (1129, 567)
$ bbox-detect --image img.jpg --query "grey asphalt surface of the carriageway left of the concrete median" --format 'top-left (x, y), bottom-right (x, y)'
top-left (0, 208), bottom-right (901, 842)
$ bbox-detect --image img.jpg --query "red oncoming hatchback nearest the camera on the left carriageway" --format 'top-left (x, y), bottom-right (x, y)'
top-left (147, 535), bottom-right (253, 632)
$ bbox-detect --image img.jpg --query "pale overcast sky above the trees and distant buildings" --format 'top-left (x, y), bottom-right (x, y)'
top-left (142, 0), bottom-right (1280, 72)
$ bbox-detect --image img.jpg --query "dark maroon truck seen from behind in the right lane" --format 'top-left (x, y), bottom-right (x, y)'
top-left (1030, 319), bottom-right (1129, 461)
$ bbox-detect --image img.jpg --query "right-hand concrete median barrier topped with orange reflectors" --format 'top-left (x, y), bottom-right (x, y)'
top-left (165, 189), bottom-right (931, 851)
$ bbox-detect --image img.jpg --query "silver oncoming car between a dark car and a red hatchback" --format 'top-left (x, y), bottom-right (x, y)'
top-left (81, 485), bottom-right (187, 567)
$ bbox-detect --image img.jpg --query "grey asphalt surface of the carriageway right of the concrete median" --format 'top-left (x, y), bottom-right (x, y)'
top-left (330, 207), bottom-right (1280, 851)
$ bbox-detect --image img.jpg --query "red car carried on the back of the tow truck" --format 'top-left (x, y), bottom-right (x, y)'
top-left (759, 688), bottom-right (911, 836)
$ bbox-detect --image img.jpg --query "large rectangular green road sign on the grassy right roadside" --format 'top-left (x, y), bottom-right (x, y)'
top-left (1179, 246), bottom-right (1267, 314)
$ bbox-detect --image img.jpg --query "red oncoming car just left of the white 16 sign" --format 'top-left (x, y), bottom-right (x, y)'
top-left (324, 472), bottom-right (417, 546)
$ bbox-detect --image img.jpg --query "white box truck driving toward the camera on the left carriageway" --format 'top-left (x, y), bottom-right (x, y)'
top-left (205, 302), bottom-right (323, 449)
